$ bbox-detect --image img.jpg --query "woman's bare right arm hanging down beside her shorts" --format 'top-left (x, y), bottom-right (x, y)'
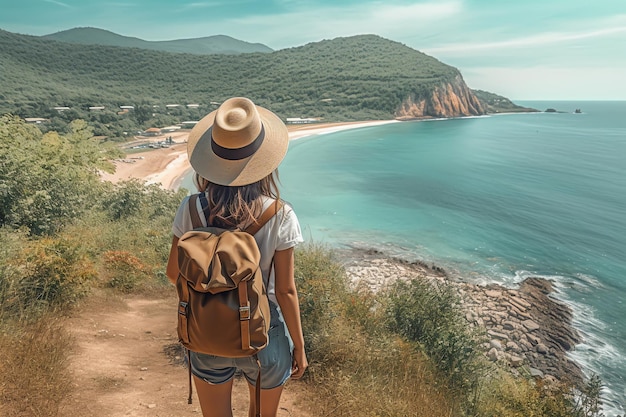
top-left (274, 248), bottom-right (309, 379)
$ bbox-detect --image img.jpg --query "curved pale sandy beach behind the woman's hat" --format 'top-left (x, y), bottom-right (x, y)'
top-left (101, 120), bottom-right (397, 189)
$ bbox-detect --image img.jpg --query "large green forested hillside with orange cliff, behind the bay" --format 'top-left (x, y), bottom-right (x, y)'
top-left (0, 31), bottom-right (528, 135)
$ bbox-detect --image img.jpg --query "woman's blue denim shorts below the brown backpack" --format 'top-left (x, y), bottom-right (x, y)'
top-left (189, 302), bottom-right (293, 389)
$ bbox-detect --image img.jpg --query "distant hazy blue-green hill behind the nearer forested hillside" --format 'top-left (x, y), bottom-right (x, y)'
top-left (42, 27), bottom-right (273, 55)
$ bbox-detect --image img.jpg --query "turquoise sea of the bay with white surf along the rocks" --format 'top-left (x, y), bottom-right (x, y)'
top-left (280, 102), bottom-right (626, 416)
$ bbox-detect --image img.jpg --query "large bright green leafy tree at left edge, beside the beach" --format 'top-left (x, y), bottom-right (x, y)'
top-left (0, 116), bottom-right (119, 235)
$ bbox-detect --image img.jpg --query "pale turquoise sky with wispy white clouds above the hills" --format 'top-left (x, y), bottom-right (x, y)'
top-left (0, 0), bottom-right (626, 100)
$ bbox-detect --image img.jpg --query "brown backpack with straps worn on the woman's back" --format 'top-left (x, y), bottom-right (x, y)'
top-left (176, 193), bottom-right (283, 412)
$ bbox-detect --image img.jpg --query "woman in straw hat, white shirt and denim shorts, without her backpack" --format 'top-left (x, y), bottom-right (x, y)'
top-left (167, 97), bottom-right (308, 417)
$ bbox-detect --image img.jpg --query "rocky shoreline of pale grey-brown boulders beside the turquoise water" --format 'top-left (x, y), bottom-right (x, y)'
top-left (337, 249), bottom-right (584, 386)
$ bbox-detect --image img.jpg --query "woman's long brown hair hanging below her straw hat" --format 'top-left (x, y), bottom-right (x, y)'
top-left (194, 170), bottom-right (280, 228)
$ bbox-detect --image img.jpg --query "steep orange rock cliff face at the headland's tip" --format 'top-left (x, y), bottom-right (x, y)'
top-left (395, 74), bottom-right (486, 119)
